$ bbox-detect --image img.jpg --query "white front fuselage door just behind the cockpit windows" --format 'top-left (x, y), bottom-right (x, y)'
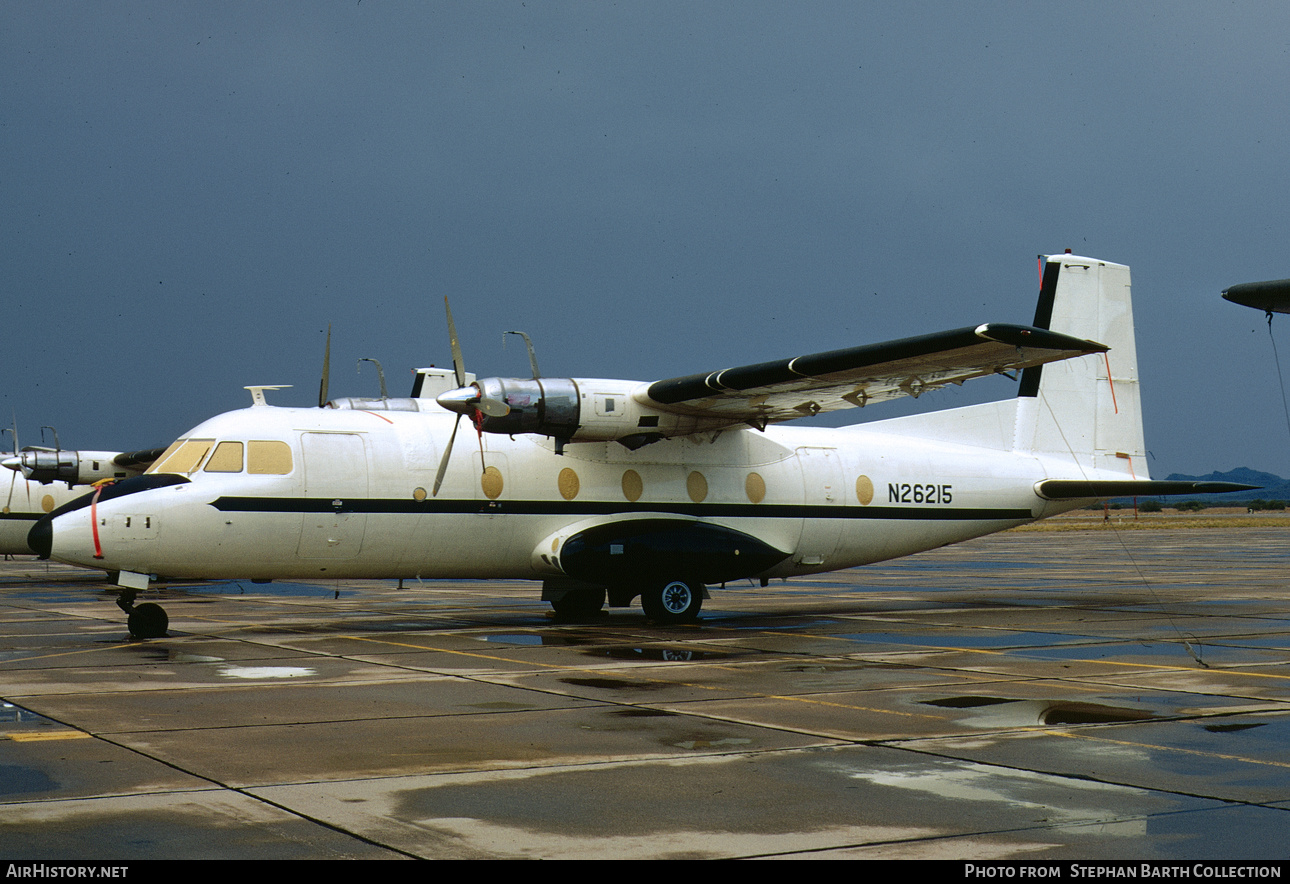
top-left (297, 432), bottom-right (368, 559)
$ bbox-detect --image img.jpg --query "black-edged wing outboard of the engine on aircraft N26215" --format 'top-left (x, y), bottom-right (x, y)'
top-left (646, 323), bottom-right (1108, 427)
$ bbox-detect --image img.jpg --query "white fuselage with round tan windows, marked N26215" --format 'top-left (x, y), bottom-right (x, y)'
top-left (37, 407), bottom-right (1078, 582)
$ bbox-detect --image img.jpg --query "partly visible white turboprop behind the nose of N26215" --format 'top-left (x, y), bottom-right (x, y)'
top-left (0, 444), bottom-right (163, 556)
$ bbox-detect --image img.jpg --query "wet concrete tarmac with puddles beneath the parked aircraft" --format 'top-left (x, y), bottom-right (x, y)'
top-left (0, 528), bottom-right (1290, 859)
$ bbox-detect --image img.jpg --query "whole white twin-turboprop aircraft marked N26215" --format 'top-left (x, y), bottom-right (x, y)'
top-left (28, 254), bottom-right (1246, 638)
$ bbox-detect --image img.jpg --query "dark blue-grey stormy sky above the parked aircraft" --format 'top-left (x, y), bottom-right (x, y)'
top-left (0, 0), bottom-right (1290, 476)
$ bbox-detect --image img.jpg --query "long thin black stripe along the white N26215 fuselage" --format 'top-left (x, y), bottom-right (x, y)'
top-left (210, 497), bottom-right (1035, 521)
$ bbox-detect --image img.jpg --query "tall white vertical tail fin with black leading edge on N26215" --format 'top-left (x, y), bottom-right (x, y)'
top-left (1015, 254), bottom-right (1148, 479)
